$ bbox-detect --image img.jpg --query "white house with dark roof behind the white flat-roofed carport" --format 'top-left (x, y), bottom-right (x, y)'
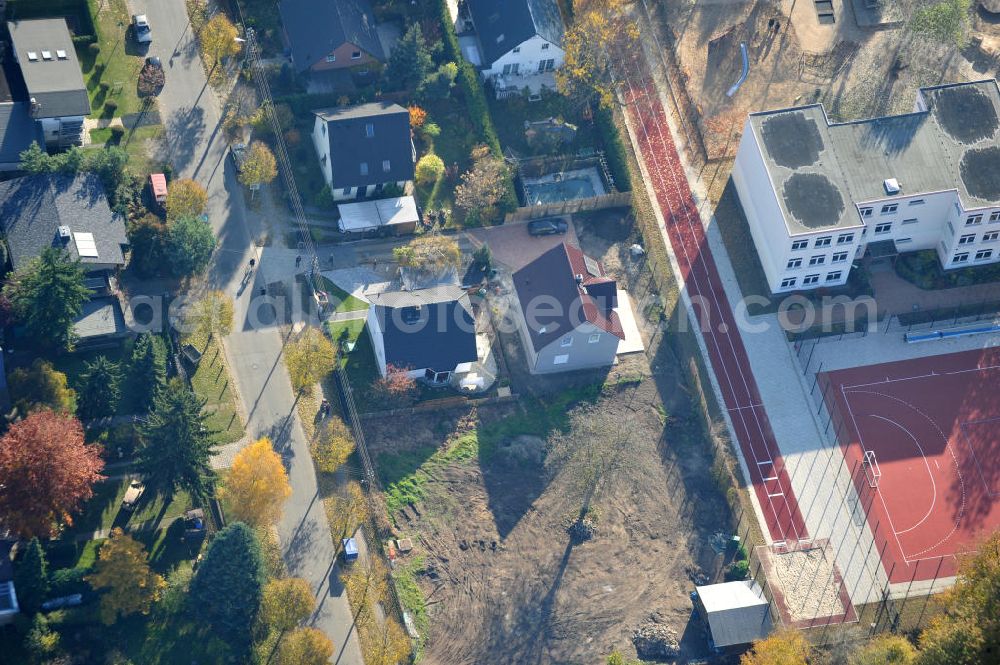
top-left (312, 102), bottom-right (417, 201)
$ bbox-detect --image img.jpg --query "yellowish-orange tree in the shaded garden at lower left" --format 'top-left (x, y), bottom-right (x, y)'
top-left (86, 528), bottom-right (167, 625)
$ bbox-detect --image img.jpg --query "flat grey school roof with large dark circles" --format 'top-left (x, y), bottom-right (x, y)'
top-left (750, 80), bottom-right (1000, 235)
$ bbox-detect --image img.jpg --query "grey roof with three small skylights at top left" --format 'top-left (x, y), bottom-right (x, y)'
top-left (7, 18), bottom-right (90, 118)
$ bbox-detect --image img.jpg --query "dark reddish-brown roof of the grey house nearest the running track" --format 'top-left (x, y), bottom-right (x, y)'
top-left (514, 243), bottom-right (625, 352)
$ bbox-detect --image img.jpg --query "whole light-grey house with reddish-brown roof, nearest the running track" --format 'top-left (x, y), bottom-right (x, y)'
top-left (514, 243), bottom-right (625, 374)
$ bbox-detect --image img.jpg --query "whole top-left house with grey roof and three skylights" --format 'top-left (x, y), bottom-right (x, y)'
top-left (7, 18), bottom-right (90, 148)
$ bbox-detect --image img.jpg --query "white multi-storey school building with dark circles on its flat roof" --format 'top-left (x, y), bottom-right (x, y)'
top-left (732, 80), bottom-right (1000, 293)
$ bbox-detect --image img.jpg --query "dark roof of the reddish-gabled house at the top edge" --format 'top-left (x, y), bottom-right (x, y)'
top-left (279, 0), bottom-right (385, 71)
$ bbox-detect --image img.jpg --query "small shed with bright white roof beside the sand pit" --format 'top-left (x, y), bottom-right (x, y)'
top-left (695, 580), bottom-right (771, 649)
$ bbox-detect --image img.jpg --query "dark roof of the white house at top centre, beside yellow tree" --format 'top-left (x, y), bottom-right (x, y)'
top-left (468, 0), bottom-right (563, 64)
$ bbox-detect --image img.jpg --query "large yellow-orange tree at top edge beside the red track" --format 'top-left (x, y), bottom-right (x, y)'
top-left (555, 0), bottom-right (641, 107)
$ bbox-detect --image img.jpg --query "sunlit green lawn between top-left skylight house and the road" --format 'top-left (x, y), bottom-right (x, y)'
top-left (76, 0), bottom-right (145, 118)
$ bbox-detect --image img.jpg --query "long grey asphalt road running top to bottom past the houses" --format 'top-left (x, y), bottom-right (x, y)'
top-left (130, 0), bottom-right (363, 665)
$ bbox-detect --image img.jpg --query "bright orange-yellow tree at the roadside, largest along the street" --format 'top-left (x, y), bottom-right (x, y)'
top-left (220, 437), bottom-right (292, 527)
